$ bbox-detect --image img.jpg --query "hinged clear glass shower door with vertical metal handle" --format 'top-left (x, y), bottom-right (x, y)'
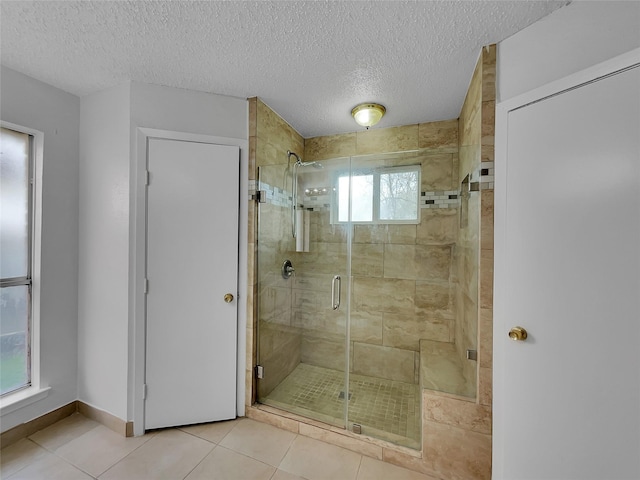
top-left (257, 156), bottom-right (350, 427)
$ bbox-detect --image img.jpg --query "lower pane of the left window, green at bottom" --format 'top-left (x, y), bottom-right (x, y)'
top-left (0, 285), bottom-right (30, 395)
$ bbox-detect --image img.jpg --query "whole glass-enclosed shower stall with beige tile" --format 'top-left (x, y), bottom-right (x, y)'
top-left (256, 150), bottom-right (477, 449)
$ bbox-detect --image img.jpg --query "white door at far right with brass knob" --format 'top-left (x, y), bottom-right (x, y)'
top-left (494, 58), bottom-right (640, 480)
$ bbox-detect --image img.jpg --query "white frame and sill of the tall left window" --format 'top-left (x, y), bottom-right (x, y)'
top-left (0, 121), bottom-right (50, 416)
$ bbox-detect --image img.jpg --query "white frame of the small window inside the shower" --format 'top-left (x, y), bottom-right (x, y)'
top-left (331, 165), bottom-right (422, 225)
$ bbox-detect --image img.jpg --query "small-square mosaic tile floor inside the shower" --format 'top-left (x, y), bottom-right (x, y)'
top-left (260, 363), bottom-right (421, 448)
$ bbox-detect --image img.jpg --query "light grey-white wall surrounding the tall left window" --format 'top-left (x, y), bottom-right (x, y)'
top-left (0, 66), bottom-right (80, 432)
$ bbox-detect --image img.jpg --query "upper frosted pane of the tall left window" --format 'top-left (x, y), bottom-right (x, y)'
top-left (0, 128), bottom-right (29, 278)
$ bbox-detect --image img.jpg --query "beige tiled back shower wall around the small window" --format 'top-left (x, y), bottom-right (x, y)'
top-left (298, 119), bottom-right (458, 383)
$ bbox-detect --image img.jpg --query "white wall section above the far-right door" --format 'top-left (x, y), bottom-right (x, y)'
top-left (497, 0), bottom-right (640, 101)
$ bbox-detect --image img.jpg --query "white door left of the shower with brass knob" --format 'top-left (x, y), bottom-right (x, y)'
top-left (145, 139), bottom-right (240, 429)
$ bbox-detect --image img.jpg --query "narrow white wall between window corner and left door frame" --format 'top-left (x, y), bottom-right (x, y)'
top-left (78, 84), bottom-right (130, 420)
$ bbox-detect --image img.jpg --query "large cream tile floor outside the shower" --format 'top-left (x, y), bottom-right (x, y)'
top-left (0, 414), bottom-right (435, 480)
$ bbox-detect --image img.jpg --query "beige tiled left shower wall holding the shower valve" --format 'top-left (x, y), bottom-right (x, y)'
top-left (245, 98), bottom-right (304, 405)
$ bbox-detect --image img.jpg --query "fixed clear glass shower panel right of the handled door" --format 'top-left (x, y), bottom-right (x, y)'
top-left (347, 154), bottom-right (422, 449)
